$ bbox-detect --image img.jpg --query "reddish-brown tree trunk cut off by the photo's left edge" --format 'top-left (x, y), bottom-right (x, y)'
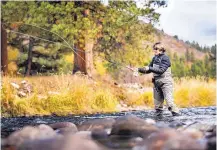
top-left (1, 25), bottom-right (8, 75)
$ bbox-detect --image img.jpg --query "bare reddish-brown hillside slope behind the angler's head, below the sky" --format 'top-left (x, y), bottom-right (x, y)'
top-left (154, 29), bottom-right (206, 60)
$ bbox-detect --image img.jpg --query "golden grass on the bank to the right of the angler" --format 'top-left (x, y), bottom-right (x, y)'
top-left (174, 77), bottom-right (216, 107)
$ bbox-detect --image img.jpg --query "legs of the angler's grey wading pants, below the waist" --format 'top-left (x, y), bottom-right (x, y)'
top-left (153, 77), bottom-right (179, 113)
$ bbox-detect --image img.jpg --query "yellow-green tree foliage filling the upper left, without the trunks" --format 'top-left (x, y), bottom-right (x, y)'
top-left (2, 1), bottom-right (162, 76)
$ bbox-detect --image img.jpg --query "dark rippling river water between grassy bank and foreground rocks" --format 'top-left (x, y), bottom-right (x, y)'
top-left (1, 106), bottom-right (216, 138)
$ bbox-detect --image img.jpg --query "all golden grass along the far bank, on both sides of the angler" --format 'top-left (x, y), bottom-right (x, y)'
top-left (1, 75), bottom-right (216, 116)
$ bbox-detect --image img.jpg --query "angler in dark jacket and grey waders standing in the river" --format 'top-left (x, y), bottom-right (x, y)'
top-left (136, 42), bottom-right (181, 116)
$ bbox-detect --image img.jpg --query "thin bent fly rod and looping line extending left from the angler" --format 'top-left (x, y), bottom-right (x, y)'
top-left (3, 22), bottom-right (135, 72)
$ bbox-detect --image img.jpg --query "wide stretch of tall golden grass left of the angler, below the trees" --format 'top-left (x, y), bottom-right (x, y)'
top-left (1, 75), bottom-right (118, 115)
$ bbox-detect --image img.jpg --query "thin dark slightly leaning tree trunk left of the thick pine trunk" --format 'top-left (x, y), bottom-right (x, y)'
top-left (25, 37), bottom-right (34, 76)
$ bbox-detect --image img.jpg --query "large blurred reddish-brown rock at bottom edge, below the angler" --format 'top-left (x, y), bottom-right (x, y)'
top-left (133, 129), bottom-right (205, 150)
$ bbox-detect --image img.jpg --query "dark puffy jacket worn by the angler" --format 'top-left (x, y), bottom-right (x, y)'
top-left (139, 53), bottom-right (171, 75)
